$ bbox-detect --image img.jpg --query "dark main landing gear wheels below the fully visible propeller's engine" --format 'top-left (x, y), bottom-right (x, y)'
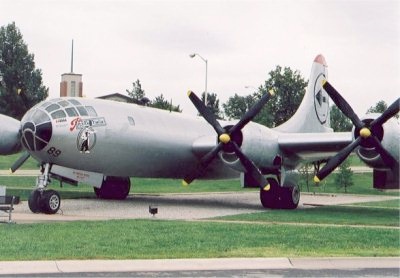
top-left (260, 178), bottom-right (300, 209)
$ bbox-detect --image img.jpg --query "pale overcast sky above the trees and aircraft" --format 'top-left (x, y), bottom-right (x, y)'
top-left (0, 0), bottom-right (400, 114)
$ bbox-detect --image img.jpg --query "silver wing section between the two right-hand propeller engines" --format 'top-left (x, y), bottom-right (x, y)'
top-left (278, 132), bottom-right (353, 164)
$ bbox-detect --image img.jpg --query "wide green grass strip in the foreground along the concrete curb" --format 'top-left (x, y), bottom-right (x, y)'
top-left (0, 220), bottom-right (400, 260)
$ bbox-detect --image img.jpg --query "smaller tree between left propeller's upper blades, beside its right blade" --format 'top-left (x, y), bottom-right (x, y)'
top-left (222, 94), bottom-right (256, 119)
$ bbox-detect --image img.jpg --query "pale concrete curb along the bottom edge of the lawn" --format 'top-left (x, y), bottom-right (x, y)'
top-left (0, 257), bottom-right (400, 275)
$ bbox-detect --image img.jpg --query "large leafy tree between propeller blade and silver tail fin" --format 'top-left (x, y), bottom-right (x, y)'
top-left (254, 66), bottom-right (308, 127)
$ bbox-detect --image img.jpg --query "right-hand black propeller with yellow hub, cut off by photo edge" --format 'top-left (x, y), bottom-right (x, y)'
top-left (314, 80), bottom-right (400, 183)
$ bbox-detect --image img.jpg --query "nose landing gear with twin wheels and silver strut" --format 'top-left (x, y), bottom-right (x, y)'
top-left (28, 163), bottom-right (61, 214)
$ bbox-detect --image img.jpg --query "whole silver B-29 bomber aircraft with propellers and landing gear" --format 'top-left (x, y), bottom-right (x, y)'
top-left (0, 55), bottom-right (400, 214)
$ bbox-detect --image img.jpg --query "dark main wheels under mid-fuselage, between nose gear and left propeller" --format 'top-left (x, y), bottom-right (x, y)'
top-left (94, 176), bottom-right (131, 200)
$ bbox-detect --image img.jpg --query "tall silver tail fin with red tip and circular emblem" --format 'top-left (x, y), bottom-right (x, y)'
top-left (275, 55), bottom-right (332, 133)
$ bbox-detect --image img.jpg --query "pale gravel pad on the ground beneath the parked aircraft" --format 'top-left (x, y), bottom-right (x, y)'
top-left (8, 191), bottom-right (398, 224)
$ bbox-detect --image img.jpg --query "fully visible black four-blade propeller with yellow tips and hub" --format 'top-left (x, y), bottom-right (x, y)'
top-left (182, 90), bottom-right (274, 191)
